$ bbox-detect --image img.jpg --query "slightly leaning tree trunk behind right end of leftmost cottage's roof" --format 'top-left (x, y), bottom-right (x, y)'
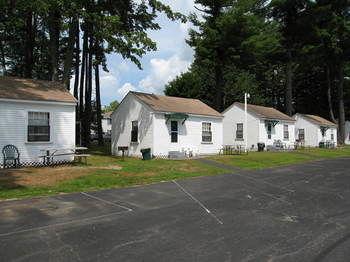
top-left (62, 17), bottom-right (78, 90)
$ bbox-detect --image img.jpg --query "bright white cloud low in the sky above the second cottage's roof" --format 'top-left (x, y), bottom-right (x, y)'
top-left (139, 55), bottom-right (191, 93)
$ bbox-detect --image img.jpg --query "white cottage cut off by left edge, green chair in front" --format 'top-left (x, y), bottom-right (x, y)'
top-left (0, 77), bottom-right (76, 165)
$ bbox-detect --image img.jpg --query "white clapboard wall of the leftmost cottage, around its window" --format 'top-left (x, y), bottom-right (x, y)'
top-left (0, 101), bottom-right (75, 164)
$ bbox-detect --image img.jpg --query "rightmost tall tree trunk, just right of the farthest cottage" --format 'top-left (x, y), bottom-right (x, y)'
top-left (338, 63), bottom-right (345, 145)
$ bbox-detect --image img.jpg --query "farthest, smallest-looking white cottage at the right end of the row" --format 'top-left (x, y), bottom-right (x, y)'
top-left (294, 113), bottom-right (337, 147)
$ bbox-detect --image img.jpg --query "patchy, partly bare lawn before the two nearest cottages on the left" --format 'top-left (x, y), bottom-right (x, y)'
top-left (0, 147), bottom-right (224, 199)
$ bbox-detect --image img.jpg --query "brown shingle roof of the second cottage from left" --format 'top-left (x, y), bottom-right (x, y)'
top-left (130, 92), bottom-right (222, 117)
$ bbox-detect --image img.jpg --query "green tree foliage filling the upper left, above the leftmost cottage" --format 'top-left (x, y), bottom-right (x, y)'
top-left (0, 0), bottom-right (186, 79)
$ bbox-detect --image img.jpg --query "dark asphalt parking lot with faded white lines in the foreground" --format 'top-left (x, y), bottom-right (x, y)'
top-left (0, 159), bottom-right (350, 262)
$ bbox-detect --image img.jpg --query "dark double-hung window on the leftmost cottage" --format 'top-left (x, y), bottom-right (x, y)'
top-left (28, 112), bottom-right (50, 142)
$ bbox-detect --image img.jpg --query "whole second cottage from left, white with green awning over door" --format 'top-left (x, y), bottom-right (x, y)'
top-left (112, 92), bottom-right (223, 157)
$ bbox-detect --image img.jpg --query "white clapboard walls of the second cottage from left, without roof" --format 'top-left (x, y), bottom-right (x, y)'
top-left (112, 93), bottom-right (222, 157)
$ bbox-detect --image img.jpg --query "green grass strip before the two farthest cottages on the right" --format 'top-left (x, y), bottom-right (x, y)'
top-left (210, 146), bottom-right (350, 169)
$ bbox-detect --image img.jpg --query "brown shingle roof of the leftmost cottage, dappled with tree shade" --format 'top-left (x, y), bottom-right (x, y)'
top-left (0, 76), bottom-right (76, 103)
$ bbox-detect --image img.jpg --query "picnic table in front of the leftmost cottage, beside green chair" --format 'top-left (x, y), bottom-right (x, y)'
top-left (39, 146), bottom-right (90, 165)
